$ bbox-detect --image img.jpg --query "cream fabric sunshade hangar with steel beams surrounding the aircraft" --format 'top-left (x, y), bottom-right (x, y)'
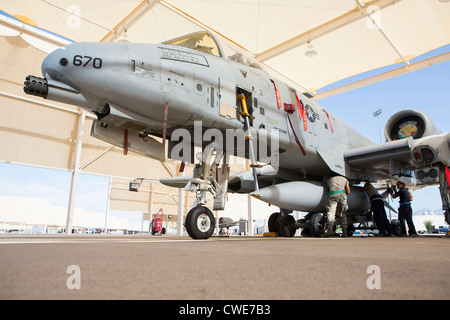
top-left (0, 0), bottom-right (450, 232)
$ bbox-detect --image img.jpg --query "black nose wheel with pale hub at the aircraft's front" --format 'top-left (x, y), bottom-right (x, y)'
top-left (185, 206), bottom-right (215, 239)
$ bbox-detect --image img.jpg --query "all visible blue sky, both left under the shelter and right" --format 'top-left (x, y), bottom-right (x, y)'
top-left (0, 45), bottom-right (450, 222)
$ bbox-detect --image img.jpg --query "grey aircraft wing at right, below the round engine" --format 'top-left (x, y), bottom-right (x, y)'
top-left (344, 133), bottom-right (450, 184)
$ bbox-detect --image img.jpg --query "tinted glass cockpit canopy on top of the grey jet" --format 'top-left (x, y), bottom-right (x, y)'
top-left (163, 31), bottom-right (262, 69)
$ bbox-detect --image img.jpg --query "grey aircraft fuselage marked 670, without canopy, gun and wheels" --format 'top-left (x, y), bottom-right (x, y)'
top-left (35, 37), bottom-right (372, 179)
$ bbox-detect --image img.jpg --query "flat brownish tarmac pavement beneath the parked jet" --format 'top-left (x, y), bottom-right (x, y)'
top-left (0, 235), bottom-right (450, 300)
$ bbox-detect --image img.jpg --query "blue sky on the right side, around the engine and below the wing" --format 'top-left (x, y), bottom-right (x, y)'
top-left (318, 45), bottom-right (450, 212)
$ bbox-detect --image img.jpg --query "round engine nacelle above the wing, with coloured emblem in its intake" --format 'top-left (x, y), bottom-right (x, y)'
top-left (384, 110), bottom-right (441, 141)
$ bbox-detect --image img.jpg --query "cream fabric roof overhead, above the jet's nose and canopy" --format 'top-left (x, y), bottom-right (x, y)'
top-left (1, 0), bottom-right (450, 97)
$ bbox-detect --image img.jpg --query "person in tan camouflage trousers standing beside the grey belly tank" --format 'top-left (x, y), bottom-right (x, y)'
top-left (322, 175), bottom-right (350, 238)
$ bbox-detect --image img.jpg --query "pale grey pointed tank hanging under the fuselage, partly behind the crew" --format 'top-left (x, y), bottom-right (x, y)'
top-left (253, 181), bottom-right (370, 212)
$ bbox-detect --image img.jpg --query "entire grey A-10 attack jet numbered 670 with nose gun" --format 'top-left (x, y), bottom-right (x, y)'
top-left (24, 32), bottom-right (450, 239)
